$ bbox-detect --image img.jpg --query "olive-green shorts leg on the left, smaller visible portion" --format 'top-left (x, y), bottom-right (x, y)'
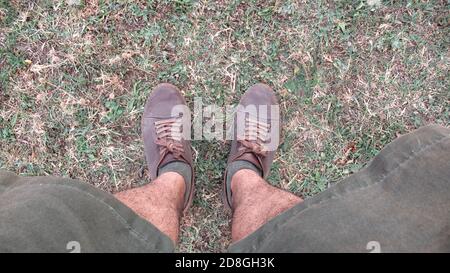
top-left (0, 171), bottom-right (174, 252)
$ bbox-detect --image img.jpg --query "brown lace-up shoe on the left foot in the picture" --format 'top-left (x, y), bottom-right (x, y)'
top-left (142, 83), bottom-right (194, 212)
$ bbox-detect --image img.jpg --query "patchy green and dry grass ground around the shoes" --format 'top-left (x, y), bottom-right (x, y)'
top-left (0, 0), bottom-right (450, 252)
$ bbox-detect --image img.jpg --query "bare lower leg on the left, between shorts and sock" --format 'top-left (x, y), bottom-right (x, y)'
top-left (114, 172), bottom-right (186, 244)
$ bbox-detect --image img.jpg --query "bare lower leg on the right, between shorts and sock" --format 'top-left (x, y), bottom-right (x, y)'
top-left (231, 169), bottom-right (303, 242)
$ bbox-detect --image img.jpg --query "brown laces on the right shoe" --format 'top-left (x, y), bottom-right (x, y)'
top-left (238, 117), bottom-right (270, 156)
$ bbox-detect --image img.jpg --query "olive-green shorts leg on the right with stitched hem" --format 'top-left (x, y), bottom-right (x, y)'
top-left (229, 125), bottom-right (450, 252)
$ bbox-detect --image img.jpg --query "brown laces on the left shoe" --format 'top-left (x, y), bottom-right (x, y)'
top-left (155, 118), bottom-right (184, 159)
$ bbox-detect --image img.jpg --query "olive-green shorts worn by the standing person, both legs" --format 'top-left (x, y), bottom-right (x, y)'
top-left (0, 125), bottom-right (450, 252)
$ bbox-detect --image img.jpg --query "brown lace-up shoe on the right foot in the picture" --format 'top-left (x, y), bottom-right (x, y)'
top-left (223, 84), bottom-right (280, 209)
